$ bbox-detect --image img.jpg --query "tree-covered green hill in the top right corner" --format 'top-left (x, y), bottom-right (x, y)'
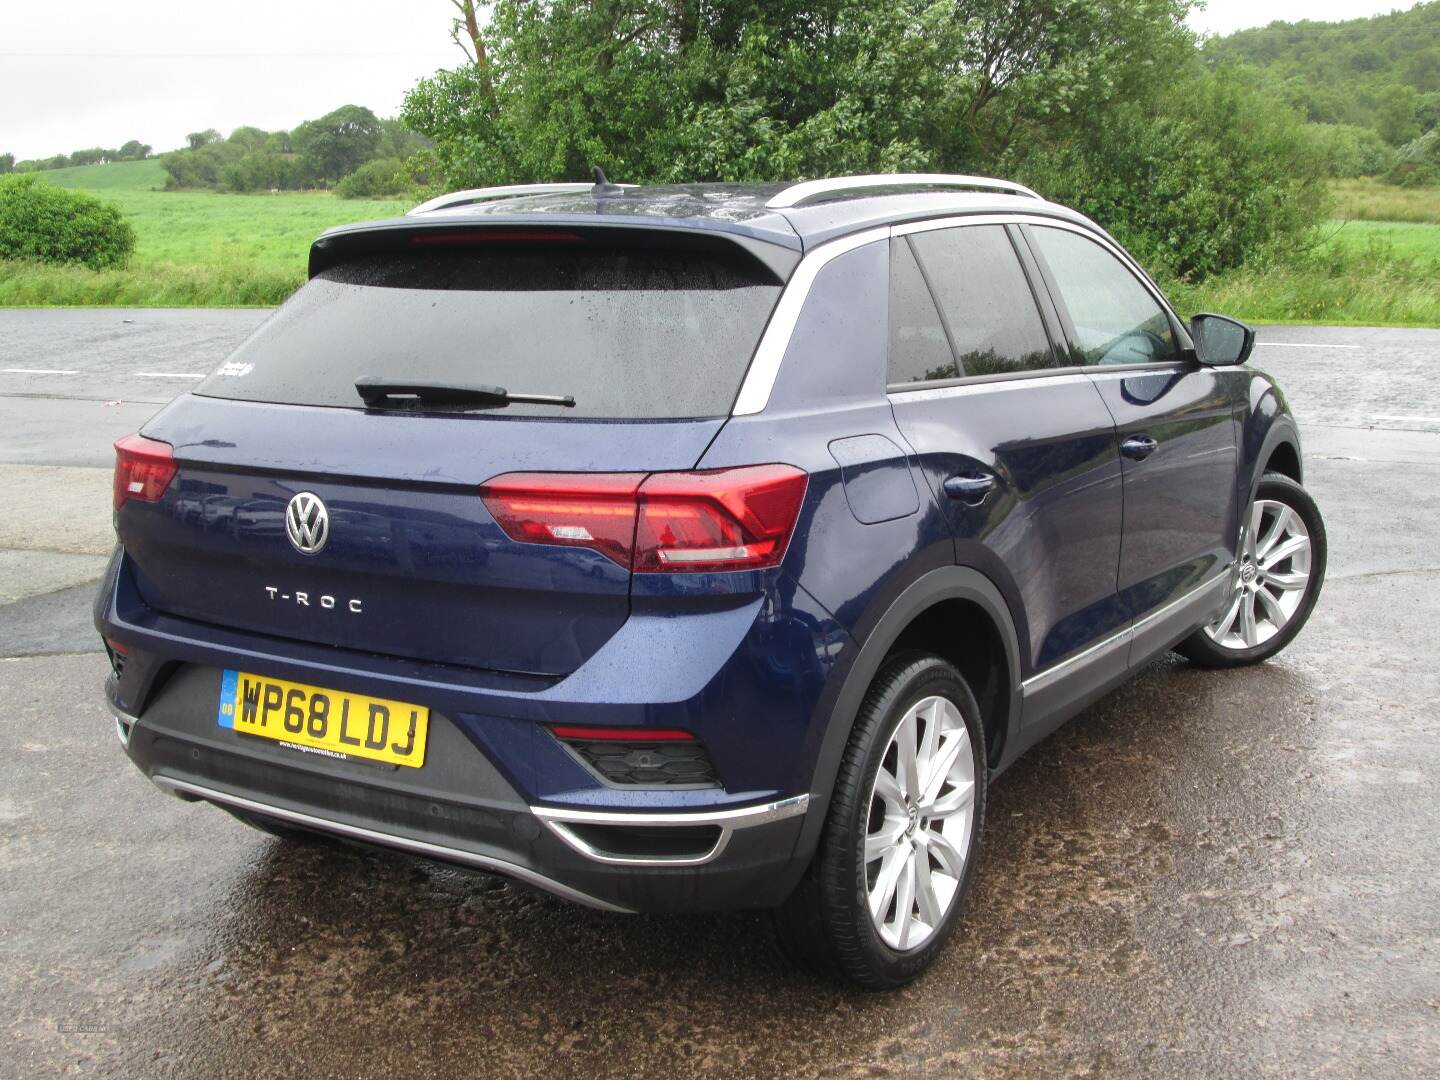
top-left (1205, 3), bottom-right (1440, 145)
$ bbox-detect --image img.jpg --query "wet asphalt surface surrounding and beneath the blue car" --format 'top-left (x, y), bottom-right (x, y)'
top-left (0, 311), bottom-right (1440, 1077)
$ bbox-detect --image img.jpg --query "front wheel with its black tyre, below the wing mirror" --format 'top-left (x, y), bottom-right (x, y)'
top-left (1175, 472), bottom-right (1326, 668)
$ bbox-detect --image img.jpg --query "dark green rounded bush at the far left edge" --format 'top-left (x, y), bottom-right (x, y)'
top-left (0, 174), bottom-right (135, 269)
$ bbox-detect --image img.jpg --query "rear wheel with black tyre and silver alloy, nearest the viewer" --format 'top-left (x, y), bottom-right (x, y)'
top-left (773, 652), bottom-right (986, 991)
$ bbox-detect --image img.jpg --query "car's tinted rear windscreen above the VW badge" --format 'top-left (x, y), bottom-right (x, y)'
top-left (196, 245), bottom-right (780, 419)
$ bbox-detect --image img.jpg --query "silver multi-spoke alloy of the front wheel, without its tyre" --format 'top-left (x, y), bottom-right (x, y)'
top-left (1205, 498), bottom-right (1310, 651)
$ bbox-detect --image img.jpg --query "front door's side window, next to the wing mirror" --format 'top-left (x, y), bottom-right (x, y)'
top-left (1031, 226), bottom-right (1179, 364)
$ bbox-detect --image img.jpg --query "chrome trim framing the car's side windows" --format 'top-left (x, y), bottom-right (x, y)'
top-left (730, 213), bottom-right (1184, 416)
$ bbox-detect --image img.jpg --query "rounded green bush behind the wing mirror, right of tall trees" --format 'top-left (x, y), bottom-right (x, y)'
top-left (1012, 66), bottom-right (1328, 281)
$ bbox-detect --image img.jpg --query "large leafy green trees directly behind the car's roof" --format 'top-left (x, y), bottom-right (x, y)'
top-left (402, 0), bottom-right (1194, 186)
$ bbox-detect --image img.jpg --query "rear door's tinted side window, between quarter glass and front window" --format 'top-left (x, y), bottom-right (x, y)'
top-left (910, 225), bottom-right (1056, 374)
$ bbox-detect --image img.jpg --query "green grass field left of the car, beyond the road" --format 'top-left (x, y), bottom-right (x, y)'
top-left (0, 160), bottom-right (412, 307)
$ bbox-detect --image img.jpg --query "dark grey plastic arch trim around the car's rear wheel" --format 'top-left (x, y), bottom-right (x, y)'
top-left (796, 566), bottom-right (1021, 861)
